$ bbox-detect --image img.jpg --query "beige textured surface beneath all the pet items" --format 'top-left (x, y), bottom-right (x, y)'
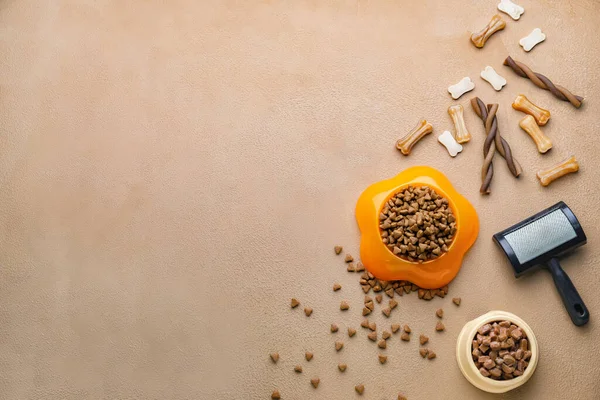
top-left (0, 0), bottom-right (600, 400)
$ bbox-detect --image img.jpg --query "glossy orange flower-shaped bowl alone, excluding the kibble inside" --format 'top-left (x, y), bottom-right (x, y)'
top-left (356, 167), bottom-right (479, 289)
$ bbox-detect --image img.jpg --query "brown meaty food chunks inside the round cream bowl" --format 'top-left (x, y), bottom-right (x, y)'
top-left (471, 321), bottom-right (531, 380)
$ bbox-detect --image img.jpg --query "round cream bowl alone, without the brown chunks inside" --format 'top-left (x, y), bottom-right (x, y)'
top-left (456, 311), bottom-right (539, 393)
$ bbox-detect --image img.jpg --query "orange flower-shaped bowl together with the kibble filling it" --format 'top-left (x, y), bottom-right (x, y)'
top-left (356, 167), bottom-right (479, 289)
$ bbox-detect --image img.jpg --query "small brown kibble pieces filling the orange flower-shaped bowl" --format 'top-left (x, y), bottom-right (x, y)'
top-left (373, 186), bottom-right (456, 264)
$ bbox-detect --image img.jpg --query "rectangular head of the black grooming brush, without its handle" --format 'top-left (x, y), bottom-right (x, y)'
top-left (494, 201), bottom-right (587, 276)
